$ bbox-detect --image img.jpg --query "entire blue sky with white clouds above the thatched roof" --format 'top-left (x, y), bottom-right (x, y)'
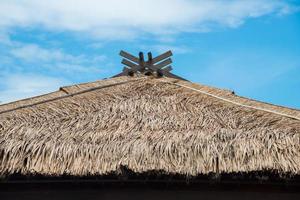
top-left (0, 0), bottom-right (300, 109)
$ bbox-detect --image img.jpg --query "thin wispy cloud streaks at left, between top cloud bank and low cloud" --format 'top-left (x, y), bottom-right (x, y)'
top-left (0, 37), bottom-right (108, 75)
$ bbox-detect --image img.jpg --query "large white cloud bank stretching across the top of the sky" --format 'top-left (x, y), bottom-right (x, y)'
top-left (0, 0), bottom-right (295, 39)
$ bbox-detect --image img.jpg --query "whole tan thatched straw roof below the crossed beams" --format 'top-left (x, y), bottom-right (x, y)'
top-left (0, 76), bottom-right (300, 176)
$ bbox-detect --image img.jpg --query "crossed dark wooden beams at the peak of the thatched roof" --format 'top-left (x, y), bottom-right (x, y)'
top-left (113, 51), bottom-right (186, 81)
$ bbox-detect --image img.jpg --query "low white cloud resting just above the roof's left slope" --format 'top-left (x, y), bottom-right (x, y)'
top-left (0, 74), bottom-right (69, 104)
